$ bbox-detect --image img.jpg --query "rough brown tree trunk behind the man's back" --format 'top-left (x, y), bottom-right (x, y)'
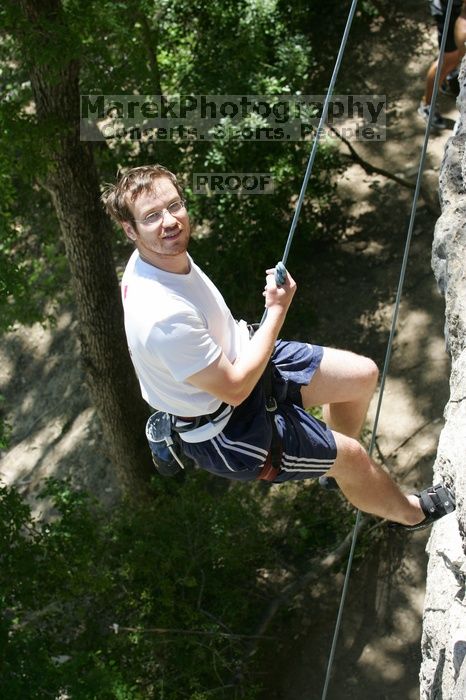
top-left (18, 0), bottom-right (154, 494)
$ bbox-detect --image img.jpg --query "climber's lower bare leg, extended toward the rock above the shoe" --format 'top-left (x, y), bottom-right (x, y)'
top-left (326, 432), bottom-right (425, 525)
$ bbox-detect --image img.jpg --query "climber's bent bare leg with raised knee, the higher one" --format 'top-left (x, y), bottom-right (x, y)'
top-left (301, 348), bottom-right (379, 438)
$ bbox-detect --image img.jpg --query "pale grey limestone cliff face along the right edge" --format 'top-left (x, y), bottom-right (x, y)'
top-left (420, 67), bottom-right (466, 700)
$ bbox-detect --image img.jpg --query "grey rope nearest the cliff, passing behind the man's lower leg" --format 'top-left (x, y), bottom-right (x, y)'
top-left (322, 0), bottom-right (453, 700)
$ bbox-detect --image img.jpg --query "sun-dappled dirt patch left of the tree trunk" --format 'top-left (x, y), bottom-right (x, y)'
top-left (0, 311), bottom-right (118, 505)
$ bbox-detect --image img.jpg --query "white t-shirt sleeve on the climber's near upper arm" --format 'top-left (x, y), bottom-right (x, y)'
top-left (146, 310), bottom-right (222, 382)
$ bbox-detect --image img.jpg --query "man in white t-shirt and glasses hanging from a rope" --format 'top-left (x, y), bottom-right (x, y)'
top-left (102, 165), bottom-right (455, 529)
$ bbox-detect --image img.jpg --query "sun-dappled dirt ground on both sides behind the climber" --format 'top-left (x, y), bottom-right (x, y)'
top-left (0, 0), bottom-right (456, 700)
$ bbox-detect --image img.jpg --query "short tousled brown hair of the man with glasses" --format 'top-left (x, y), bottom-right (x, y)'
top-left (101, 164), bottom-right (183, 224)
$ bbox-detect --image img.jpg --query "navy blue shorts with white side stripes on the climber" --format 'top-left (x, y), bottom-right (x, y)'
top-left (182, 340), bottom-right (337, 483)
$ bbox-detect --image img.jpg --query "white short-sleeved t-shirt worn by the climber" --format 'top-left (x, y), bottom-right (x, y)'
top-left (121, 250), bottom-right (249, 416)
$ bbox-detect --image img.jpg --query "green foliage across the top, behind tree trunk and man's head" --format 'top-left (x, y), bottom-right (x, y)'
top-left (0, 0), bottom-right (354, 330)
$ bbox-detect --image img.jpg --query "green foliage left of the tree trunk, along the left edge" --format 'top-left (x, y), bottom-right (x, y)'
top-left (0, 21), bottom-right (69, 332)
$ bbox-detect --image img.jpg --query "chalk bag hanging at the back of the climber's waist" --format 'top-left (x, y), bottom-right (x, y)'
top-left (146, 411), bottom-right (184, 476)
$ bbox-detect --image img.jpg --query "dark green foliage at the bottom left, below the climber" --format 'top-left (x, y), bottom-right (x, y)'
top-left (0, 473), bottom-right (349, 700)
